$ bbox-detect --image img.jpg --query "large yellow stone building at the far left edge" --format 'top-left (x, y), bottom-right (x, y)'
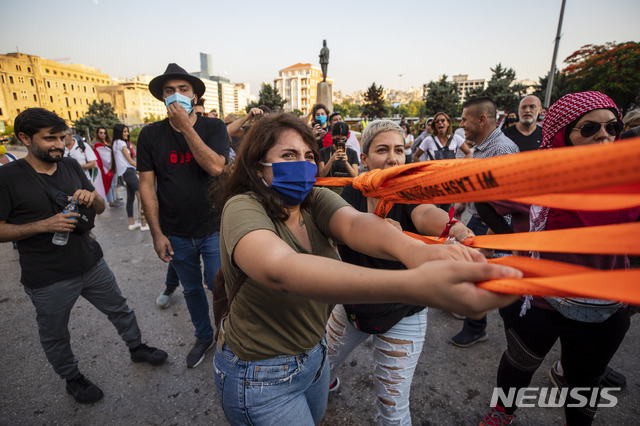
top-left (0, 52), bottom-right (110, 125)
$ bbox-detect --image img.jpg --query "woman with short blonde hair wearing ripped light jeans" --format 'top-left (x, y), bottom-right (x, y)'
top-left (327, 120), bottom-right (473, 425)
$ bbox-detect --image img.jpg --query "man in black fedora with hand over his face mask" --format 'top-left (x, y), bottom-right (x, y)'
top-left (138, 63), bottom-right (229, 368)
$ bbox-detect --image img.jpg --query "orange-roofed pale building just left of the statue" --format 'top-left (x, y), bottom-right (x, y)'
top-left (273, 63), bottom-right (333, 114)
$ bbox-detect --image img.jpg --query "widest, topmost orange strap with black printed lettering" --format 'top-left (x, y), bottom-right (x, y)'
top-left (353, 138), bottom-right (640, 215)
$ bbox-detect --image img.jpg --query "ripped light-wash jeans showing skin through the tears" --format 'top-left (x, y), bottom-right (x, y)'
top-left (327, 305), bottom-right (427, 426)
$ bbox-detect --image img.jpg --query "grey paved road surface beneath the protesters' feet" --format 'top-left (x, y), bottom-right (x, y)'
top-left (0, 158), bottom-right (640, 426)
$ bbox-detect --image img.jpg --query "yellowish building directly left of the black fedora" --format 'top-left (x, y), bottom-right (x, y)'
top-left (97, 74), bottom-right (167, 126)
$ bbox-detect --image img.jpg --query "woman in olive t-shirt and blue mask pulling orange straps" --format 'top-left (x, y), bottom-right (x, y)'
top-left (210, 114), bottom-right (521, 425)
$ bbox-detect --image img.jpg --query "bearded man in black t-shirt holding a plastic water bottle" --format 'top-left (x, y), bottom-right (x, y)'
top-left (0, 108), bottom-right (167, 404)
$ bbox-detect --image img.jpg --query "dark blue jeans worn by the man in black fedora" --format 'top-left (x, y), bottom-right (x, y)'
top-left (168, 232), bottom-right (220, 341)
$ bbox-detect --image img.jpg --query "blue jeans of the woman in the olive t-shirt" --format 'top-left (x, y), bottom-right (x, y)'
top-left (213, 338), bottom-right (329, 426)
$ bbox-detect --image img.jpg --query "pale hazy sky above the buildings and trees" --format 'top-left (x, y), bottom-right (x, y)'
top-left (0, 0), bottom-right (640, 94)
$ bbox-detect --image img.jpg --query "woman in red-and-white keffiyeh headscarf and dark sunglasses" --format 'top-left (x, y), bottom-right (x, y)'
top-left (480, 92), bottom-right (640, 425)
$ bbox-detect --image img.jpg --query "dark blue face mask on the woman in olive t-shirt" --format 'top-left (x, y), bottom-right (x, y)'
top-left (260, 161), bottom-right (318, 206)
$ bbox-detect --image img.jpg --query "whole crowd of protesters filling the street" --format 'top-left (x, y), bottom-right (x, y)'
top-left (0, 60), bottom-right (640, 425)
